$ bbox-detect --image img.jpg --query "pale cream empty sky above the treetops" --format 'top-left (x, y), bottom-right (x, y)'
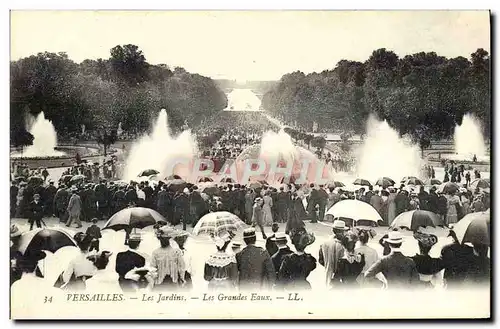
top-left (11, 11), bottom-right (490, 82)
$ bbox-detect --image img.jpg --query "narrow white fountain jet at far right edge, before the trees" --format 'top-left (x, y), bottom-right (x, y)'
top-left (443, 113), bottom-right (490, 162)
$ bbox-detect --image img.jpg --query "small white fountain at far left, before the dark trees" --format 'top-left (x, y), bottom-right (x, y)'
top-left (10, 112), bottom-right (65, 158)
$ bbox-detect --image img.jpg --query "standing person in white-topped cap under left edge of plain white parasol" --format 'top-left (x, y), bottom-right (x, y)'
top-left (318, 219), bottom-right (349, 287)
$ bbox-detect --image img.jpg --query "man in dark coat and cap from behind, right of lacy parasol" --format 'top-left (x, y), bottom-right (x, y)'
top-left (236, 228), bottom-right (276, 291)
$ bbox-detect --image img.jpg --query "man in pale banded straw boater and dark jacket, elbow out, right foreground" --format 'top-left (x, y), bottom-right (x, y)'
top-left (365, 231), bottom-right (420, 288)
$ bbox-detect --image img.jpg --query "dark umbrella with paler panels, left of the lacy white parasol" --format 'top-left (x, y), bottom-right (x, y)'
top-left (103, 207), bottom-right (167, 231)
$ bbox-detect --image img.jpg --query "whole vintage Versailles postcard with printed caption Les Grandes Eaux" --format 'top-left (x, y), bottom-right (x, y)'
top-left (10, 10), bottom-right (492, 320)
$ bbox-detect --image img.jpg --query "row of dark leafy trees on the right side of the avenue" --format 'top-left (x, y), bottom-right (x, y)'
top-left (262, 49), bottom-right (491, 148)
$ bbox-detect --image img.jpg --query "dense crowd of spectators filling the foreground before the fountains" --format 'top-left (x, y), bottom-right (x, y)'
top-left (11, 127), bottom-right (490, 292)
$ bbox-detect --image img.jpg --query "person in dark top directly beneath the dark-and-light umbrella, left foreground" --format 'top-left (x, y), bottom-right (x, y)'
top-left (115, 234), bottom-right (146, 292)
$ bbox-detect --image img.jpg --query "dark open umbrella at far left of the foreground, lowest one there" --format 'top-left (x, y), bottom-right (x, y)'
top-left (18, 228), bottom-right (77, 254)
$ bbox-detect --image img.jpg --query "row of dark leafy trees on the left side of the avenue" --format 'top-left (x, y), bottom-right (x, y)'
top-left (10, 44), bottom-right (227, 147)
